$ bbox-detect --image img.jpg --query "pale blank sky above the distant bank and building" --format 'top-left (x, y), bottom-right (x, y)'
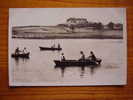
top-left (9, 8), bottom-right (126, 26)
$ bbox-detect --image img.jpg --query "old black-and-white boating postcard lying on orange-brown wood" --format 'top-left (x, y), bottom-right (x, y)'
top-left (8, 8), bottom-right (127, 86)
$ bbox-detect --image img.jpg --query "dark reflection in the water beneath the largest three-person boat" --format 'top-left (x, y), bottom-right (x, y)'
top-left (54, 65), bottom-right (101, 78)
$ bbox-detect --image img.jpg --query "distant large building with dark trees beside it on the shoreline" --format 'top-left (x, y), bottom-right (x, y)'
top-left (58, 17), bottom-right (123, 30)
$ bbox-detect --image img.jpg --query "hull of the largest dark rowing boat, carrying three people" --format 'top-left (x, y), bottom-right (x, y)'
top-left (54, 58), bottom-right (102, 67)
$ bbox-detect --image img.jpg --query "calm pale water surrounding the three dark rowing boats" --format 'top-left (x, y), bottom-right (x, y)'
top-left (9, 39), bottom-right (126, 86)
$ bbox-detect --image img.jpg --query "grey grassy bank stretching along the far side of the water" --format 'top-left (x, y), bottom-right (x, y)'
top-left (12, 26), bottom-right (123, 39)
